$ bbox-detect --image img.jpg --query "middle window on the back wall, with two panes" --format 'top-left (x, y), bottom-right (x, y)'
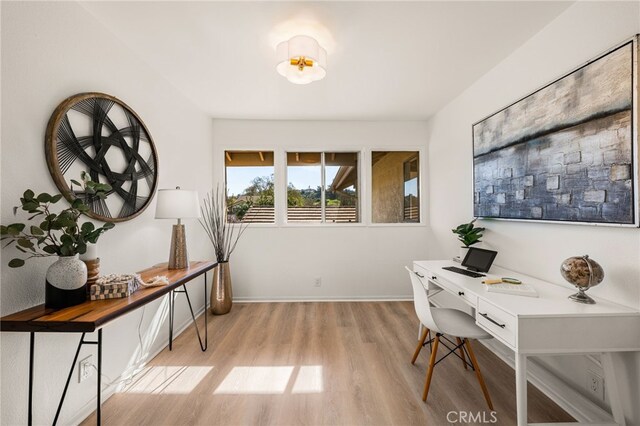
top-left (287, 152), bottom-right (360, 223)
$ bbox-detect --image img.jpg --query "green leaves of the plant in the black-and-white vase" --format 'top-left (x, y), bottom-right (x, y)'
top-left (0, 172), bottom-right (115, 268)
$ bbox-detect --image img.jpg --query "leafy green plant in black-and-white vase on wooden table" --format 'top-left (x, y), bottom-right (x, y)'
top-left (0, 172), bottom-right (114, 309)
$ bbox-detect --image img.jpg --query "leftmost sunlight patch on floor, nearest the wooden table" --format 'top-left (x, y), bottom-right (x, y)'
top-left (121, 365), bottom-right (213, 395)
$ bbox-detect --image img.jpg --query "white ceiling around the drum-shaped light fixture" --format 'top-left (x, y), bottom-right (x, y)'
top-left (81, 1), bottom-right (571, 120)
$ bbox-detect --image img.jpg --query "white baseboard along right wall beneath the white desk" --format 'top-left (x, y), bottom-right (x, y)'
top-left (479, 339), bottom-right (612, 424)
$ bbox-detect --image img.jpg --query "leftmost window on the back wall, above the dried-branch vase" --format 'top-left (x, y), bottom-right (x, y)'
top-left (225, 151), bottom-right (275, 223)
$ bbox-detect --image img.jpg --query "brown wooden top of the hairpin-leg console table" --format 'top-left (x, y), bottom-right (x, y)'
top-left (0, 261), bottom-right (217, 333)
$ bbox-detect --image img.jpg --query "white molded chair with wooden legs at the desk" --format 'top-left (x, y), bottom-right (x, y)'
top-left (405, 266), bottom-right (493, 410)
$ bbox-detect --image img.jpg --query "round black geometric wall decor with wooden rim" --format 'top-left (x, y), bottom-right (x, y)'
top-left (45, 93), bottom-right (158, 222)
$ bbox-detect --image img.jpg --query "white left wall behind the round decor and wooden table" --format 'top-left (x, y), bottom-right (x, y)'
top-left (0, 2), bottom-right (212, 425)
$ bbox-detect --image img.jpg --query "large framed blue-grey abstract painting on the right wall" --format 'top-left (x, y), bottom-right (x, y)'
top-left (473, 37), bottom-right (638, 225)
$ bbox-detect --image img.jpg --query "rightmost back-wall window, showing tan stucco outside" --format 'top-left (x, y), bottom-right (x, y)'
top-left (371, 151), bottom-right (420, 223)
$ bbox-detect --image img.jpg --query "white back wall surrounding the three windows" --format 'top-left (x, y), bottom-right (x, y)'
top-left (213, 120), bottom-right (429, 299)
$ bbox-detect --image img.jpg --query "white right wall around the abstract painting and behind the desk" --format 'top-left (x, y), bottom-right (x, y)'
top-left (428, 2), bottom-right (640, 425)
